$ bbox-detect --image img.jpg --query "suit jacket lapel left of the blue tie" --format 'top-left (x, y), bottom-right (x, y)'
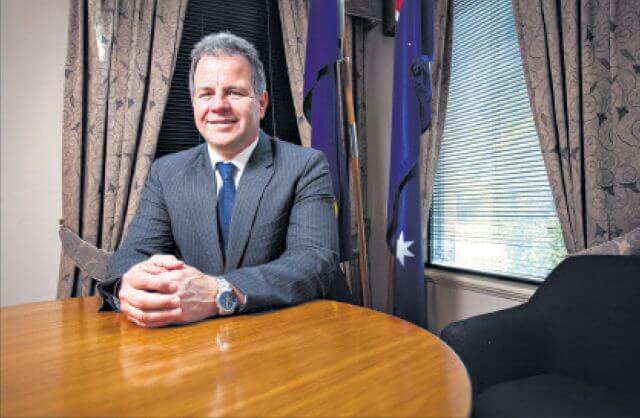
top-left (185, 143), bottom-right (224, 274)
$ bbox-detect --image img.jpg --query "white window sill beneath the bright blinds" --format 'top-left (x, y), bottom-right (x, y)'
top-left (425, 267), bottom-right (538, 303)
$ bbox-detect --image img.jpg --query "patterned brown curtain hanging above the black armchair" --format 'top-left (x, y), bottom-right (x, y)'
top-left (513, 0), bottom-right (640, 253)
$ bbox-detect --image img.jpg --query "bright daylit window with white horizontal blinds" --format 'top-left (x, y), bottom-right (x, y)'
top-left (429, 0), bottom-right (566, 281)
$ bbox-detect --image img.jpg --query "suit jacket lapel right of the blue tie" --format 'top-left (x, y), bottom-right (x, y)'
top-left (225, 131), bottom-right (273, 272)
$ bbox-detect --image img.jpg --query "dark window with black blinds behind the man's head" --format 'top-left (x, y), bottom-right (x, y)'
top-left (156, 0), bottom-right (300, 158)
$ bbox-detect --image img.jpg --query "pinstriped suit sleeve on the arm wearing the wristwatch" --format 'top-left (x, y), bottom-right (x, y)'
top-left (224, 152), bottom-right (341, 311)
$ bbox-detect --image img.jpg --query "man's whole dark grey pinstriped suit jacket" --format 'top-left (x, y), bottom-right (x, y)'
top-left (98, 132), bottom-right (346, 311)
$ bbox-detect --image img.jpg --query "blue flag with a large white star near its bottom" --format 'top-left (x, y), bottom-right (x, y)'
top-left (387, 0), bottom-right (433, 327)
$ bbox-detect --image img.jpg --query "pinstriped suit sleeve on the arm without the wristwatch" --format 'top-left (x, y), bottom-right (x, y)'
top-left (98, 162), bottom-right (175, 310)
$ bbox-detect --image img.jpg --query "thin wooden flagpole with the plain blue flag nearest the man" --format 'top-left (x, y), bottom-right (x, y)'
top-left (337, 0), bottom-right (371, 308)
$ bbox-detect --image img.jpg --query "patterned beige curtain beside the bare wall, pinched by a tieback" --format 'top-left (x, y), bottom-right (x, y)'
top-left (58, 0), bottom-right (187, 298)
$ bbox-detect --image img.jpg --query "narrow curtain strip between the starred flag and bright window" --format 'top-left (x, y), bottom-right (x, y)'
top-left (420, 0), bottom-right (453, 248)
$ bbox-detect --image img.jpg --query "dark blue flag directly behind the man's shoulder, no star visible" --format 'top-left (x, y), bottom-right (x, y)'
top-left (304, 0), bottom-right (351, 261)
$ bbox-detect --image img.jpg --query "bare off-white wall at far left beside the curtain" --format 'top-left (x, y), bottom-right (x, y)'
top-left (0, 0), bottom-right (69, 306)
